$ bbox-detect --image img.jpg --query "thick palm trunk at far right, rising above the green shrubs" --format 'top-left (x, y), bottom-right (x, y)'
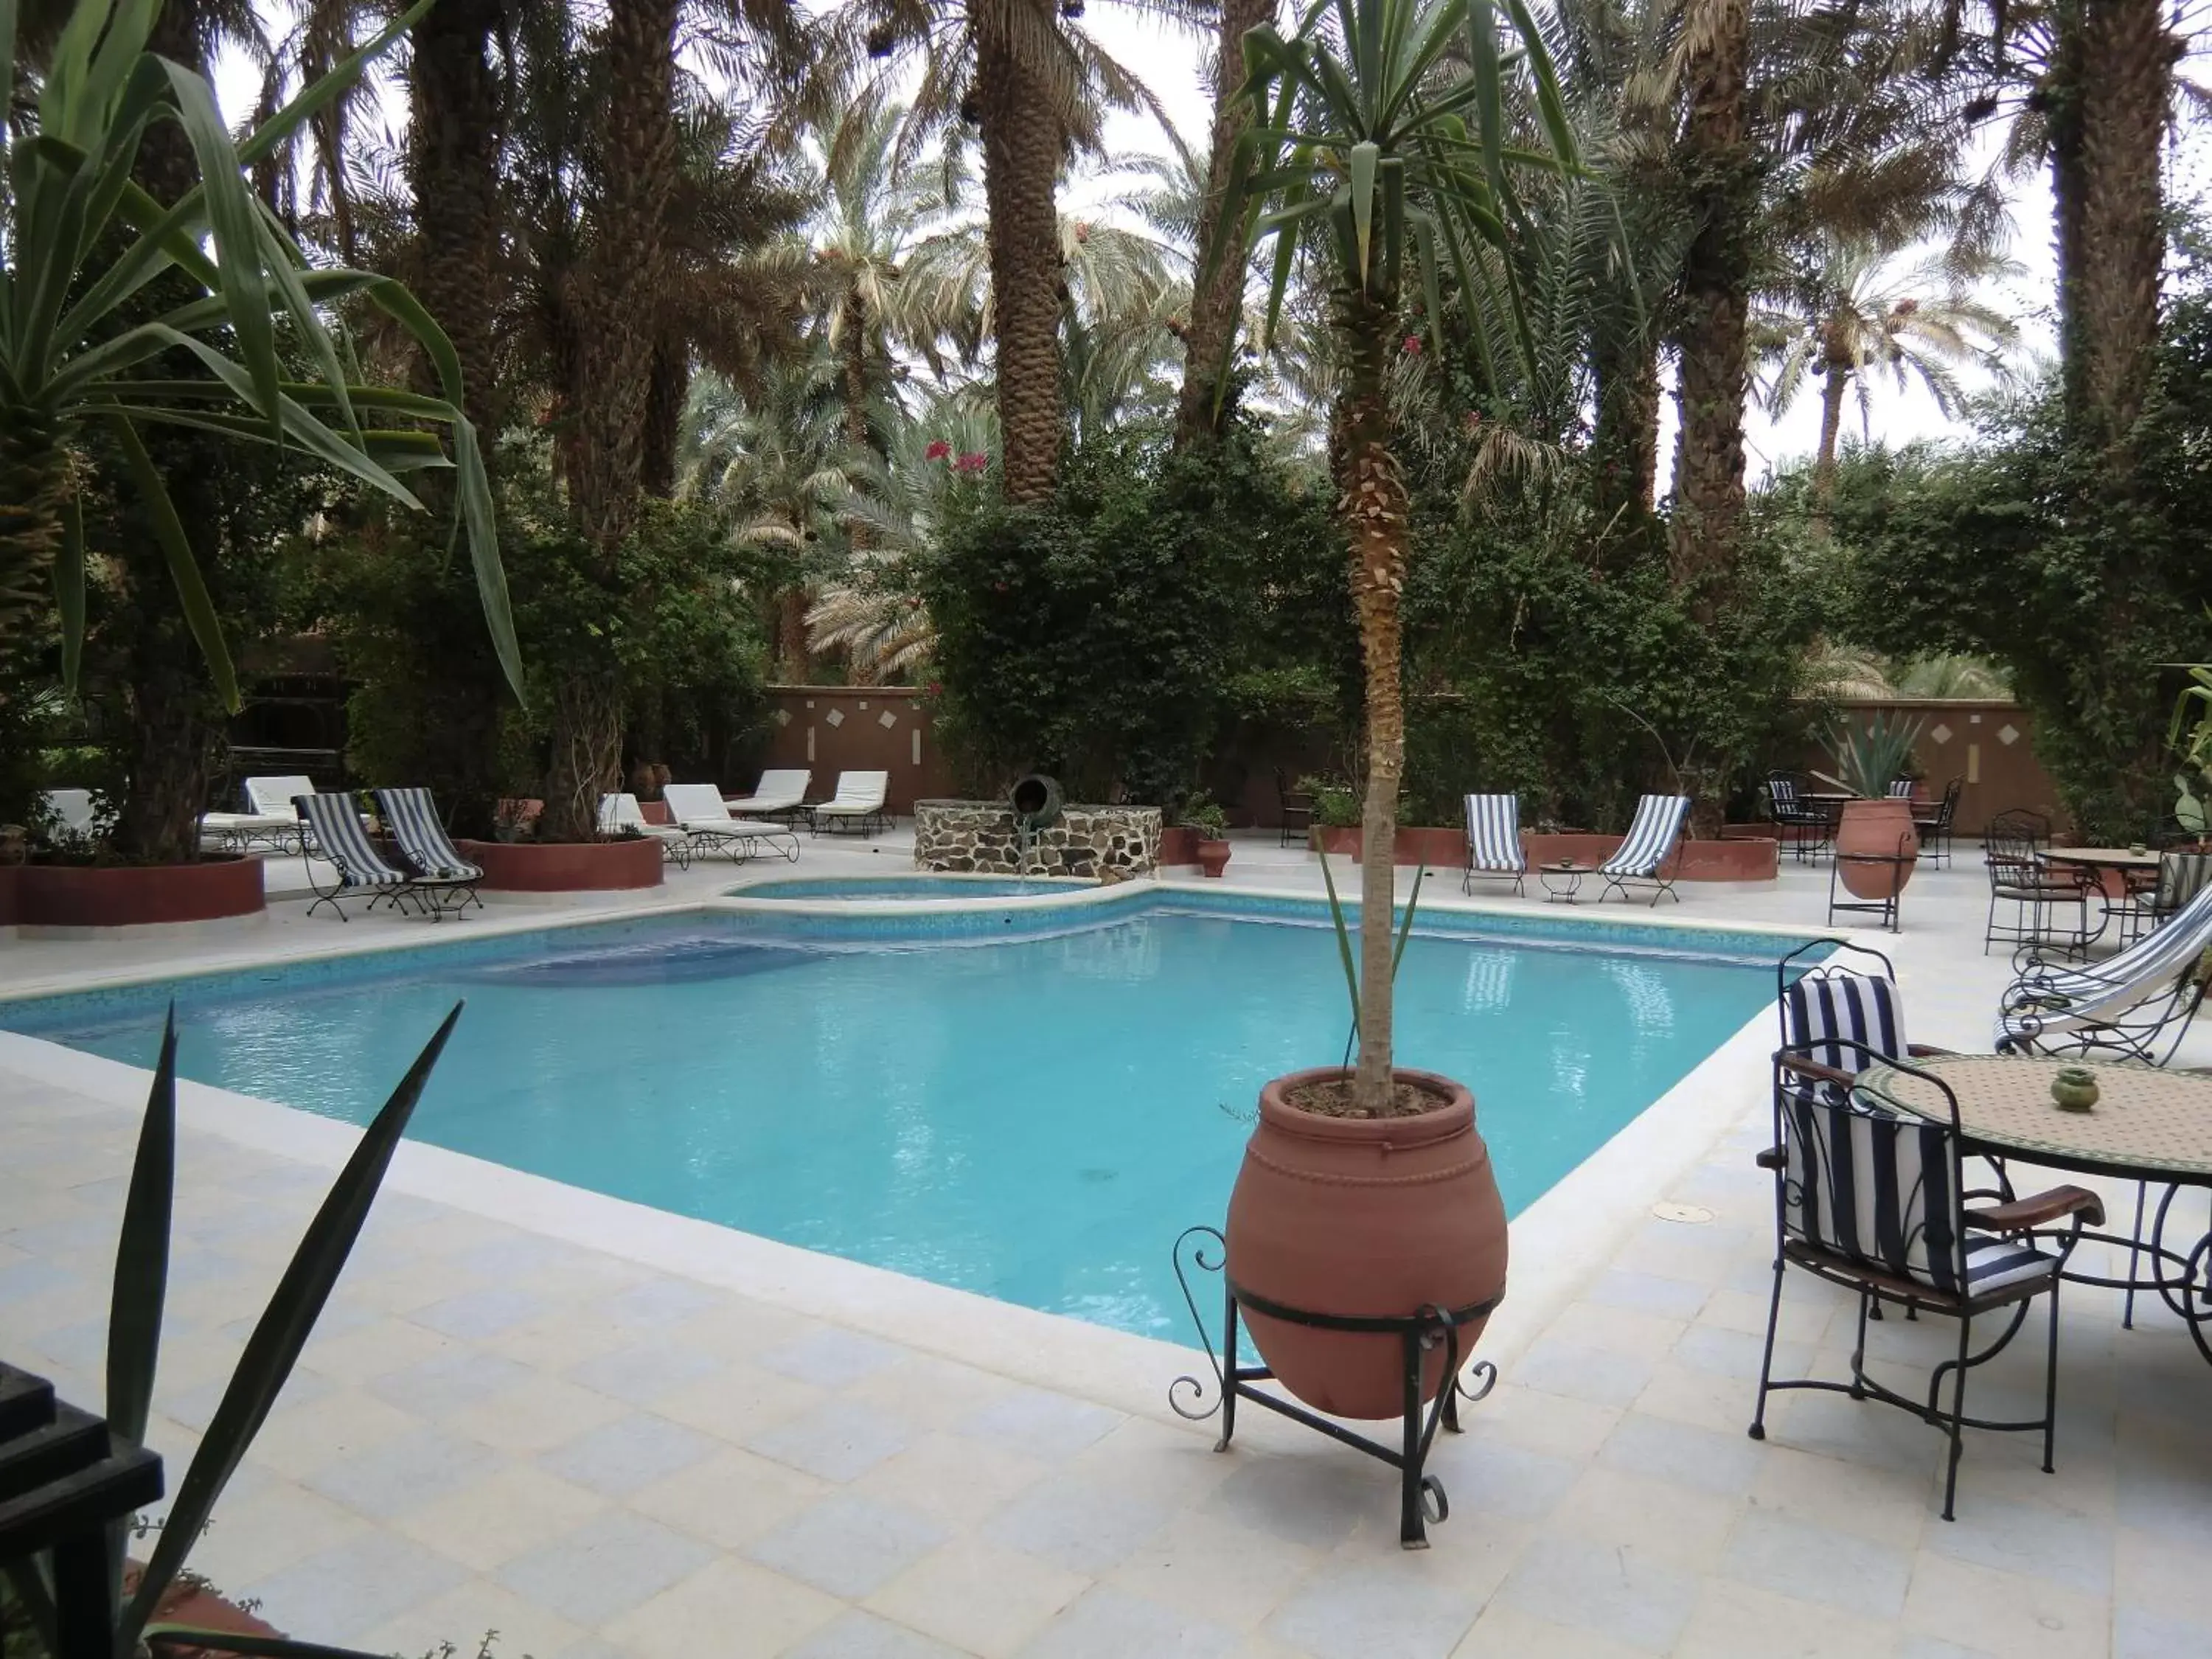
top-left (2051, 0), bottom-right (2181, 445)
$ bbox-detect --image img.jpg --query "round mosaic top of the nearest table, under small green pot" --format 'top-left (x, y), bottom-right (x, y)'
top-left (1858, 1055), bottom-right (2212, 1183)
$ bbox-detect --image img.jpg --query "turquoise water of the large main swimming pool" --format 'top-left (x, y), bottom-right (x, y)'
top-left (0, 902), bottom-right (1792, 1334)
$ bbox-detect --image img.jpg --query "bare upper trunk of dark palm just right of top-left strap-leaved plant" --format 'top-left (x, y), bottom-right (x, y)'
top-left (407, 0), bottom-right (502, 442)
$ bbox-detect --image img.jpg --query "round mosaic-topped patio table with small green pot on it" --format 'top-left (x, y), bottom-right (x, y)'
top-left (1858, 1055), bottom-right (2212, 1360)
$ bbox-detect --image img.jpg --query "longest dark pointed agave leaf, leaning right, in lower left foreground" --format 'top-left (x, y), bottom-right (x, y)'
top-left (115, 1002), bottom-right (465, 1652)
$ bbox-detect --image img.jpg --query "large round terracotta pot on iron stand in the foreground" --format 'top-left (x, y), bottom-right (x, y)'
top-left (1228, 1066), bottom-right (1506, 1418)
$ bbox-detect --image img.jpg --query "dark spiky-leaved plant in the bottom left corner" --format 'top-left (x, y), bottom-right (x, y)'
top-left (4, 1002), bottom-right (462, 1659)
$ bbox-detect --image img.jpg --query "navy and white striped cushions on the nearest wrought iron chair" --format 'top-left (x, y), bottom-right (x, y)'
top-left (1783, 1091), bottom-right (2059, 1298)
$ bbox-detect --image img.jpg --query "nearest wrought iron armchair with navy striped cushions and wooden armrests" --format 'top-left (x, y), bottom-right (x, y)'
top-left (1750, 1037), bottom-right (2104, 1520)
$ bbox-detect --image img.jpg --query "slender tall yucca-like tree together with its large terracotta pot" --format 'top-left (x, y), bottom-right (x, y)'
top-left (1210, 0), bottom-right (1575, 1418)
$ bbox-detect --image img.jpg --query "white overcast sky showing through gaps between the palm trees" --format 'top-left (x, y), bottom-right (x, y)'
top-left (215, 4), bottom-right (2212, 489)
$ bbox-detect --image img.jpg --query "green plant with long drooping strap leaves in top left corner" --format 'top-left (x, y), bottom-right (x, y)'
top-left (0, 0), bottom-right (522, 708)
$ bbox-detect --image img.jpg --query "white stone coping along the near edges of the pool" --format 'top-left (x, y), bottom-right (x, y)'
top-left (0, 905), bottom-right (1913, 1422)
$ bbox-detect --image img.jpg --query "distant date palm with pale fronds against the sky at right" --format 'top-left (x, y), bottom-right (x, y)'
top-left (1752, 237), bottom-right (2020, 529)
